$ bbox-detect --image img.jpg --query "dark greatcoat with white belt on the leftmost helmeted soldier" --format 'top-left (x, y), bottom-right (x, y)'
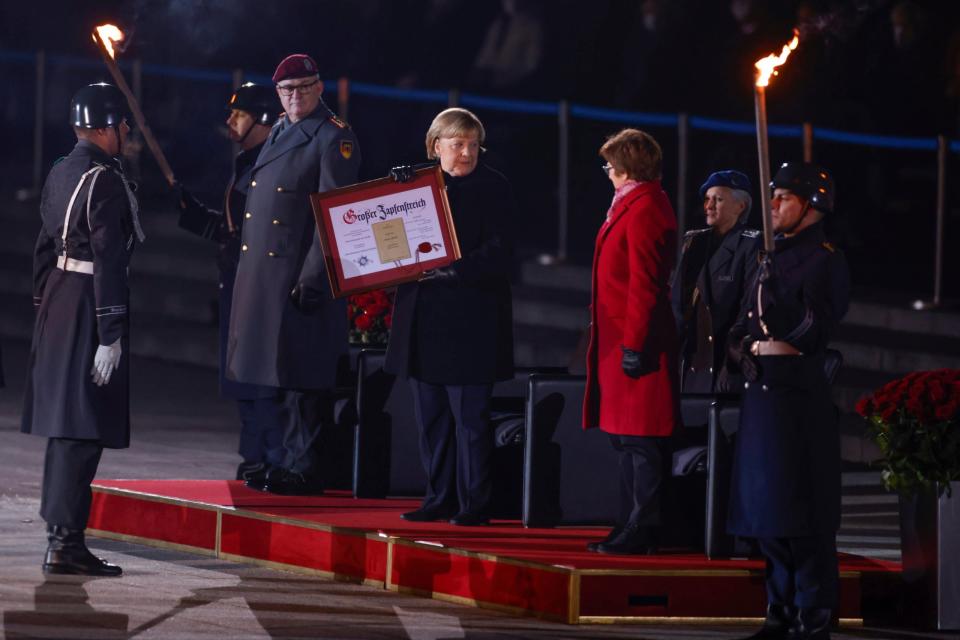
top-left (21, 141), bottom-right (134, 448)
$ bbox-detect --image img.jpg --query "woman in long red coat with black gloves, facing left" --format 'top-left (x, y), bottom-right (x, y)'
top-left (583, 129), bottom-right (679, 554)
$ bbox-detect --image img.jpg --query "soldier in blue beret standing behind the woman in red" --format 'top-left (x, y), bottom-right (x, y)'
top-left (672, 170), bottom-right (762, 393)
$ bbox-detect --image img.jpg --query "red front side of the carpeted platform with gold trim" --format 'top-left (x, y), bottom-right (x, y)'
top-left (88, 481), bottom-right (892, 624)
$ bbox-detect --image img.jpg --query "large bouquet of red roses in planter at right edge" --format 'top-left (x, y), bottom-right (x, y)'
top-left (857, 369), bottom-right (960, 495)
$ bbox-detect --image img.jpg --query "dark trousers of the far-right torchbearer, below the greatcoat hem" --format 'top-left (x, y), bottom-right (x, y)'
top-left (757, 533), bottom-right (840, 609)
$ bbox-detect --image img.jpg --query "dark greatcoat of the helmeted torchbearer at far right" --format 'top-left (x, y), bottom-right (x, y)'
top-left (728, 223), bottom-right (850, 538)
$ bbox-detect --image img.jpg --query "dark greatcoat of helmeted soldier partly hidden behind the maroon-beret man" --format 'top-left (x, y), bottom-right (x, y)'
top-left (179, 144), bottom-right (276, 400)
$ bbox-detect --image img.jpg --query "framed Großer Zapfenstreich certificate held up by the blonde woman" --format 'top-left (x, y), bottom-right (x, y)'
top-left (310, 166), bottom-right (460, 298)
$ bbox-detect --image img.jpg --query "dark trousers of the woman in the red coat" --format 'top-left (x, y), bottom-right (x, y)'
top-left (609, 434), bottom-right (665, 527)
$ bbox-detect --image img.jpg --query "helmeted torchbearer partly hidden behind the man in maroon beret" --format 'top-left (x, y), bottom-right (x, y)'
top-left (177, 82), bottom-right (284, 483)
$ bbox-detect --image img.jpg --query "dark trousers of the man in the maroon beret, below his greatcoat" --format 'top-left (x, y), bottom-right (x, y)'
top-left (282, 389), bottom-right (333, 474)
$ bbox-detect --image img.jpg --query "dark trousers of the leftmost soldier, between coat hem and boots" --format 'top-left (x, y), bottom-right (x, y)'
top-left (40, 438), bottom-right (103, 529)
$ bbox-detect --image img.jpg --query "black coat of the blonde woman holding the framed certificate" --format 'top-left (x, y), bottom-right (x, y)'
top-left (385, 163), bottom-right (517, 385)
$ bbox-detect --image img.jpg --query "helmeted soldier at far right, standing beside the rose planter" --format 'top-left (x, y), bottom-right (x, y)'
top-left (728, 162), bottom-right (850, 639)
